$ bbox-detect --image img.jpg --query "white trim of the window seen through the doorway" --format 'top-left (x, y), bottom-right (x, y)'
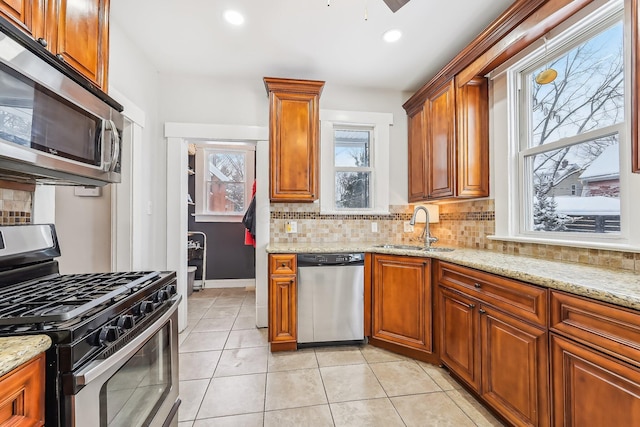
top-left (194, 142), bottom-right (256, 222)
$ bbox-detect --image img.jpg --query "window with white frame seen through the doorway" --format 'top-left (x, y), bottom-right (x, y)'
top-left (195, 143), bottom-right (255, 222)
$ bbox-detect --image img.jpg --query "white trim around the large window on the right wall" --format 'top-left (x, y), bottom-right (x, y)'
top-left (487, 1), bottom-right (640, 252)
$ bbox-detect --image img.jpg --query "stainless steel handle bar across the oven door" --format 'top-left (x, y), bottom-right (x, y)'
top-left (73, 295), bottom-right (182, 386)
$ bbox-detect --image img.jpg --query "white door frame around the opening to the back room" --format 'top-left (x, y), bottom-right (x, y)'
top-left (164, 123), bottom-right (270, 331)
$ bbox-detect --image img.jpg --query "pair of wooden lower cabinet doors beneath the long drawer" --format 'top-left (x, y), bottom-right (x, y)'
top-left (439, 287), bottom-right (550, 426)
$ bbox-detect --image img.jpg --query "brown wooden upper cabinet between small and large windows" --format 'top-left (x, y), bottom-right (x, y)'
top-left (408, 77), bottom-right (489, 202)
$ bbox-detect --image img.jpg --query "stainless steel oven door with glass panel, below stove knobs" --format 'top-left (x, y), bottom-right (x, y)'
top-left (71, 296), bottom-right (180, 427)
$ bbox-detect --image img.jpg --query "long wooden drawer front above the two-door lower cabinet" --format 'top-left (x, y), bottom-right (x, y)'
top-left (438, 262), bottom-right (547, 326)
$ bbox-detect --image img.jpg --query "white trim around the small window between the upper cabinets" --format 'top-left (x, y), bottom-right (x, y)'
top-left (320, 110), bottom-right (393, 215)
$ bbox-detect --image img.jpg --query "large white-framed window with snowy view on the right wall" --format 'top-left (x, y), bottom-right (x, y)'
top-left (492, 1), bottom-right (637, 247)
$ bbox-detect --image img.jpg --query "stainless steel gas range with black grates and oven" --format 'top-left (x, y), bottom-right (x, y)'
top-left (0, 225), bottom-right (181, 427)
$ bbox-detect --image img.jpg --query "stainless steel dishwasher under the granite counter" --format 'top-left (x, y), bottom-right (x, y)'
top-left (298, 253), bottom-right (364, 346)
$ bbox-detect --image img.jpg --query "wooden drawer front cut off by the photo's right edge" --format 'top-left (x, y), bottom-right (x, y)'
top-left (551, 291), bottom-right (640, 366)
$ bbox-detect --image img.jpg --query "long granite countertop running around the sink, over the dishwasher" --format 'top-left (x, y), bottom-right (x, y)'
top-left (267, 242), bottom-right (640, 310)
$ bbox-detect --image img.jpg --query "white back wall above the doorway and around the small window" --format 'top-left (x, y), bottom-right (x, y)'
top-left (160, 74), bottom-right (408, 205)
